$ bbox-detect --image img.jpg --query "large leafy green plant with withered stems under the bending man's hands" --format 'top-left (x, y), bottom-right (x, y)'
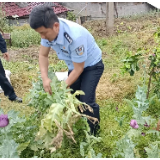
top-left (27, 67), bottom-right (100, 158)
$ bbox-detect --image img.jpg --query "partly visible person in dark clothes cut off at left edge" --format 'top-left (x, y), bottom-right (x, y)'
top-left (0, 34), bottom-right (22, 103)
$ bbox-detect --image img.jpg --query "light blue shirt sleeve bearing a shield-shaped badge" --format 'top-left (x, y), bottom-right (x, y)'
top-left (70, 36), bottom-right (87, 63)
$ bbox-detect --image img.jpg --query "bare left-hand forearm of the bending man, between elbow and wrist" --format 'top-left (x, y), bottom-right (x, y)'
top-left (39, 56), bottom-right (49, 79)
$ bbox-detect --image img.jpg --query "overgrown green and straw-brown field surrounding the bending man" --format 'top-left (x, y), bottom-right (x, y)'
top-left (0, 13), bottom-right (160, 158)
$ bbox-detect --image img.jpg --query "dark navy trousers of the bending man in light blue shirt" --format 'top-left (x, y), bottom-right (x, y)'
top-left (68, 60), bottom-right (104, 133)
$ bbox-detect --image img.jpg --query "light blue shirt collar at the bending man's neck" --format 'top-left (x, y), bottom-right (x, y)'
top-left (52, 20), bottom-right (64, 45)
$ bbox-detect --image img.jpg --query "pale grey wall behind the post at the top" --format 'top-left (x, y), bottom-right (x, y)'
top-left (59, 2), bottom-right (154, 19)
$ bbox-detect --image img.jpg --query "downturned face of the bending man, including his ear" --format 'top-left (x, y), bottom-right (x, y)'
top-left (35, 22), bottom-right (59, 41)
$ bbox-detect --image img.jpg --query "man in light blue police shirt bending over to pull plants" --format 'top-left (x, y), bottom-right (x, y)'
top-left (29, 5), bottom-right (104, 134)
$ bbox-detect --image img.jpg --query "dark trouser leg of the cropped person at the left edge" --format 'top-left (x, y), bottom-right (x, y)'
top-left (0, 59), bottom-right (16, 100)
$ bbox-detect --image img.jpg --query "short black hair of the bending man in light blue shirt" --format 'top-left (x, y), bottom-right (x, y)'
top-left (29, 5), bottom-right (59, 29)
